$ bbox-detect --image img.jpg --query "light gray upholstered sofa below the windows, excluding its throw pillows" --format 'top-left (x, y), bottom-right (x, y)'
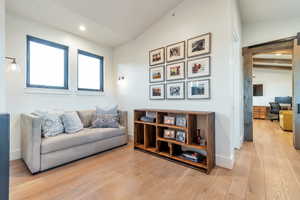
top-left (21, 110), bottom-right (128, 174)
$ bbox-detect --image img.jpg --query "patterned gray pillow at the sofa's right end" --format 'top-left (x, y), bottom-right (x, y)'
top-left (92, 114), bottom-right (119, 128)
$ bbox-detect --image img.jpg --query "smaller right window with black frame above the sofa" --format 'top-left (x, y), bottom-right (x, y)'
top-left (78, 50), bottom-right (103, 91)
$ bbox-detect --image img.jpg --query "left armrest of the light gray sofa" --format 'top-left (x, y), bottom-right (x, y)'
top-left (21, 114), bottom-right (42, 173)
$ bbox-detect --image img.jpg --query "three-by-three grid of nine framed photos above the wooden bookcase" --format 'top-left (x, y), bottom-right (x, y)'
top-left (149, 33), bottom-right (212, 100)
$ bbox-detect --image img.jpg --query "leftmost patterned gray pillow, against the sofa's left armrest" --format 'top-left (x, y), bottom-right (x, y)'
top-left (41, 113), bottom-right (64, 137)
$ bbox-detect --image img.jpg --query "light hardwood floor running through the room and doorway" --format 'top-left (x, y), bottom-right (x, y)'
top-left (10, 120), bottom-right (300, 200)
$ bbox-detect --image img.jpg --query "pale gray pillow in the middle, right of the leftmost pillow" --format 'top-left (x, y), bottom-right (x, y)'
top-left (62, 112), bottom-right (83, 133)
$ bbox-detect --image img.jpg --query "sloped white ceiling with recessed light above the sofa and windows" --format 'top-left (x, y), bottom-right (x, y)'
top-left (6, 0), bottom-right (183, 47)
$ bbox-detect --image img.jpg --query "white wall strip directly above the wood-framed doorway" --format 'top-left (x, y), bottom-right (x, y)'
top-left (243, 18), bottom-right (300, 46)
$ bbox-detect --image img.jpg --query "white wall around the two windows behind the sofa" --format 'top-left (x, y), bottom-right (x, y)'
top-left (6, 14), bottom-right (116, 159)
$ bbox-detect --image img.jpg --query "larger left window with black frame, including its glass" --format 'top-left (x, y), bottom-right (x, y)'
top-left (26, 36), bottom-right (69, 89)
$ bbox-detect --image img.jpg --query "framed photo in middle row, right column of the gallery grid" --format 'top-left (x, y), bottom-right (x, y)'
top-left (187, 56), bottom-right (210, 78)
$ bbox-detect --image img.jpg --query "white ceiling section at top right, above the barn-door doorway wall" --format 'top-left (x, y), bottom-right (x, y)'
top-left (239, 0), bottom-right (300, 23)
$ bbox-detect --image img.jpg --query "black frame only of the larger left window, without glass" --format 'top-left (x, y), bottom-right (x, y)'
top-left (26, 35), bottom-right (69, 90)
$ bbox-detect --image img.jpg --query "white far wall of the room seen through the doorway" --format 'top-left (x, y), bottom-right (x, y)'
top-left (253, 68), bottom-right (293, 106)
